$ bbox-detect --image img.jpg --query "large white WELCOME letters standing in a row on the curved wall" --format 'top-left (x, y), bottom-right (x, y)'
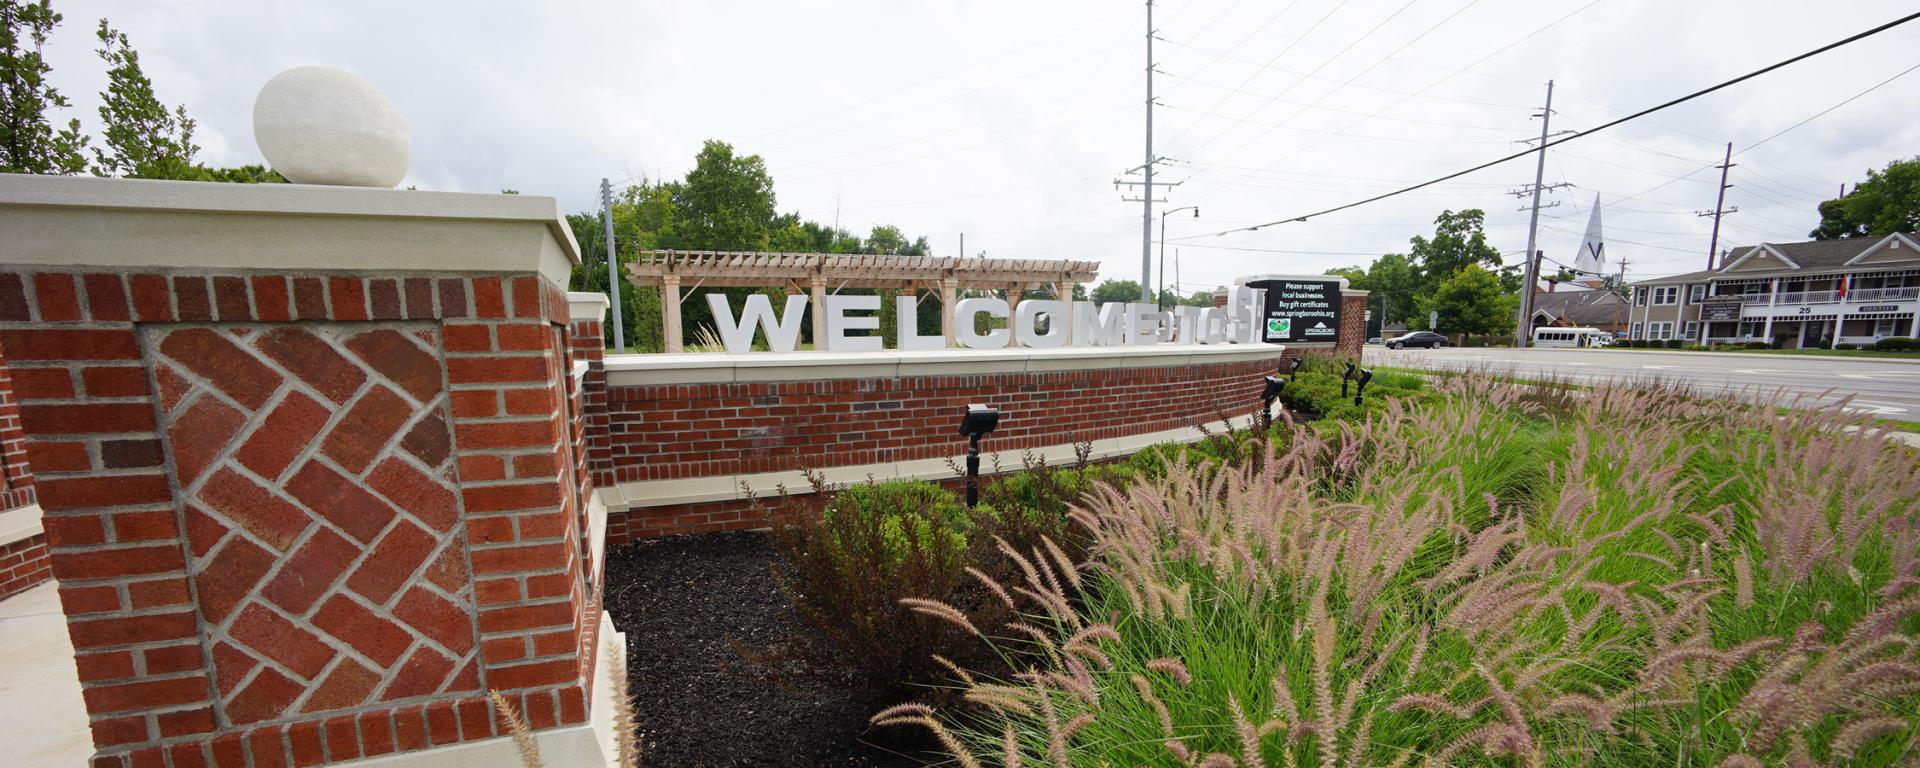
top-left (707, 286), bottom-right (1290, 353)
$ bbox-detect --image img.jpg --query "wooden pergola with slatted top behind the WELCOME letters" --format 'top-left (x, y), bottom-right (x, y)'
top-left (626, 252), bottom-right (1100, 351)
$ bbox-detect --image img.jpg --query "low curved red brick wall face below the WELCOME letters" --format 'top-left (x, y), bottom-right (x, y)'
top-left (597, 355), bottom-right (1283, 484)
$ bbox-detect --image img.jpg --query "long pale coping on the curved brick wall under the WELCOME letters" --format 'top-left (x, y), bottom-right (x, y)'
top-left (607, 344), bottom-right (1286, 386)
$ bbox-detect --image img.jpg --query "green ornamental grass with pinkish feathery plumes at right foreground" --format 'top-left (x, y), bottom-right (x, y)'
top-left (876, 376), bottom-right (1920, 768)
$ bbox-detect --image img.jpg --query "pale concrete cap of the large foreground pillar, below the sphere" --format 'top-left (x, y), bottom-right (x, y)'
top-left (0, 173), bottom-right (580, 286)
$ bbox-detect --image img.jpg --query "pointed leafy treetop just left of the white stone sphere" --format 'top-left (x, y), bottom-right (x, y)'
top-left (94, 19), bottom-right (205, 179)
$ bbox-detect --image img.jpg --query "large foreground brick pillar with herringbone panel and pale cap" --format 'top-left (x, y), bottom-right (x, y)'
top-left (0, 177), bottom-right (601, 768)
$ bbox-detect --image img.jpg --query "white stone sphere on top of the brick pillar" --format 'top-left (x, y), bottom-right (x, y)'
top-left (253, 67), bottom-right (413, 188)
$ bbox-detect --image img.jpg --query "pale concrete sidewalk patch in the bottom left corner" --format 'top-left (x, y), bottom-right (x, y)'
top-left (0, 582), bottom-right (94, 768)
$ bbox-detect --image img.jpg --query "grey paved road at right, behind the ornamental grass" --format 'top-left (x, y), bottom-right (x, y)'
top-left (1363, 346), bottom-right (1920, 420)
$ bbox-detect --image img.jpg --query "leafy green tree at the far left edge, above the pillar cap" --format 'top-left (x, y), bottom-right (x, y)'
top-left (0, 0), bottom-right (86, 175)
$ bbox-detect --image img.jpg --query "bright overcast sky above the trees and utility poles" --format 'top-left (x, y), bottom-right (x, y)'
top-left (33, 0), bottom-right (1920, 290)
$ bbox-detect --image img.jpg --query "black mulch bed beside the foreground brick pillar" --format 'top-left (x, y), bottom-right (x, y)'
top-left (607, 532), bottom-right (950, 768)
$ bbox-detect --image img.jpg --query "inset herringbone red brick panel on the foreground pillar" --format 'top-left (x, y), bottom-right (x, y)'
top-left (146, 324), bottom-right (480, 724)
